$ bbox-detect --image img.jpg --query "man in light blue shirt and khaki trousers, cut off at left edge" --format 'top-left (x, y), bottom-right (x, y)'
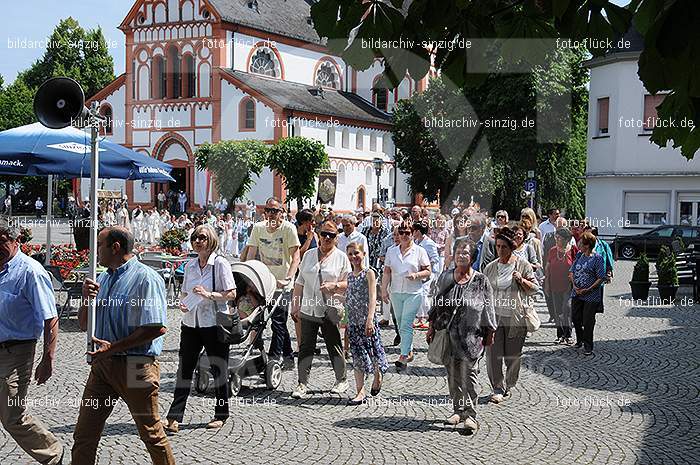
top-left (0, 220), bottom-right (63, 465)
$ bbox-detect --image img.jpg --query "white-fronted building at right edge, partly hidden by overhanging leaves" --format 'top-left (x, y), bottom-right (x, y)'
top-left (586, 26), bottom-right (700, 236)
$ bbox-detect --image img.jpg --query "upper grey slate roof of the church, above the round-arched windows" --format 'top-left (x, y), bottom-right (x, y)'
top-left (209, 0), bottom-right (323, 44)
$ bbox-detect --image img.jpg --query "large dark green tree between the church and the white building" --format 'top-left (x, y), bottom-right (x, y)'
top-left (393, 46), bottom-right (587, 217)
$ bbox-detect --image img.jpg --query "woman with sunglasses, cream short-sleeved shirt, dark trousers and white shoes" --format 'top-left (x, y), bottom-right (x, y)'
top-left (292, 220), bottom-right (350, 399)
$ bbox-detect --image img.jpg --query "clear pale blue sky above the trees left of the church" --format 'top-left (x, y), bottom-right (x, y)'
top-left (0, 0), bottom-right (629, 85)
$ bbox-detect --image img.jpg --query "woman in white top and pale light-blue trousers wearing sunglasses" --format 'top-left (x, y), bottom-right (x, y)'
top-left (382, 222), bottom-right (431, 369)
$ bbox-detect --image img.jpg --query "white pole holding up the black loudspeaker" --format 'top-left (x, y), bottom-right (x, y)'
top-left (87, 102), bottom-right (100, 363)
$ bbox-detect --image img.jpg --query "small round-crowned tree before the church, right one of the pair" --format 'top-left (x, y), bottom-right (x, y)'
top-left (267, 137), bottom-right (330, 209)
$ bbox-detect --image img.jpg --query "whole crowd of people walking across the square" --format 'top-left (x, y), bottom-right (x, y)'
top-left (0, 197), bottom-right (614, 464)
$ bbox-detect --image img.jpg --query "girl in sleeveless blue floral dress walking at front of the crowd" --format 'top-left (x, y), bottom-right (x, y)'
top-left (346, 242), bottom-right (388, 405)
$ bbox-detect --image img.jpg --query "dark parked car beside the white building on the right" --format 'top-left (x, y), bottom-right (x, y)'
top-left (613, 225), bottom-right (700, 259)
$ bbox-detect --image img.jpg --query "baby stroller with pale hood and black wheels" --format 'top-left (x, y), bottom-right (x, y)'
top-left (194, 260), bottom-right (282, 396)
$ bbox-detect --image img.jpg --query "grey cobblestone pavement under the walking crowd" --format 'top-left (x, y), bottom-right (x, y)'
top-left (0, 262), bottom-right (700, 464)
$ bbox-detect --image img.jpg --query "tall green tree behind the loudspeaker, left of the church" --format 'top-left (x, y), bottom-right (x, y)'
top-left (18, 17), bottom-right (114, 98)
